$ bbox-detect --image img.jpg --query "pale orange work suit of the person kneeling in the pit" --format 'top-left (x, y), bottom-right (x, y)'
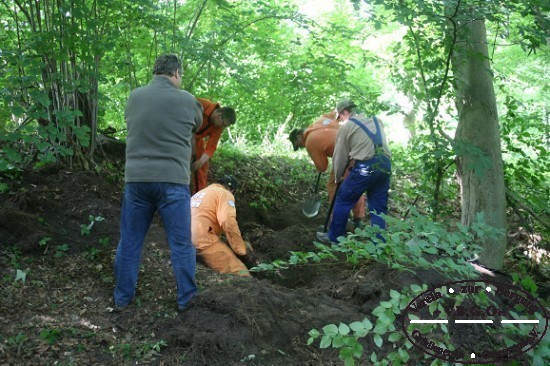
top-left (191, 184), bottom-right (250, 276)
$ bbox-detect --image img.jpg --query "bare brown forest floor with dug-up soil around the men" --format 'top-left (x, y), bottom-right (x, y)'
top-left (0, 147), bottom-right (548, 365)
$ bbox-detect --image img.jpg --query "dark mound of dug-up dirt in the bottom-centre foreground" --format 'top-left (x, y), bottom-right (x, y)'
top-left (155, 279), bottom-right (361, 365)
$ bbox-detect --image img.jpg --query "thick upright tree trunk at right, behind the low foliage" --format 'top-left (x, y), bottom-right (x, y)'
top-left (452, 20), bottom-right (506, 269)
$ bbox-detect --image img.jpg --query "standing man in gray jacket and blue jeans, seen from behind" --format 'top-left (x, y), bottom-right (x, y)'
top-left (114, 55), bottom-right (202, 310)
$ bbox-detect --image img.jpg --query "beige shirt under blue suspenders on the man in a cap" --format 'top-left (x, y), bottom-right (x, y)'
top-left (332, 113), bottom-right (391, 181)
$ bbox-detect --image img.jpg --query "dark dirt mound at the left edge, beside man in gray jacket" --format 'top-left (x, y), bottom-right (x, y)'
top-left (0, 168), bottom-right (121, 254)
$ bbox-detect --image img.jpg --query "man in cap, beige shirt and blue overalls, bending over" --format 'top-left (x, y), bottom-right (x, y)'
top-left (315, 99), bottom-right (391, 243)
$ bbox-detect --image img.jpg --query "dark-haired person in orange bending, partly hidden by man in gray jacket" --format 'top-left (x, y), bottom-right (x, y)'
top-left (191, 98), bottom-right (237, 194)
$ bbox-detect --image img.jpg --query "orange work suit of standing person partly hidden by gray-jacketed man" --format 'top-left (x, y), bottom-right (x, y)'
top-left (191, 98), bottom-right (223, 194)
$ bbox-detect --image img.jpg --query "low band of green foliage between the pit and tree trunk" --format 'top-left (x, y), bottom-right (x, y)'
top-left (252, 210), bottom-right (495, 278)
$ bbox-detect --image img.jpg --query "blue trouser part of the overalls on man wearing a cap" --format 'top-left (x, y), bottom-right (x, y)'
top-left (328, 155), bottom-right (391, 242)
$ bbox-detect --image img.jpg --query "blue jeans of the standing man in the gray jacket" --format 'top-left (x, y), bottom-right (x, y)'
top-left (114, 182), bottom-right (198, 308)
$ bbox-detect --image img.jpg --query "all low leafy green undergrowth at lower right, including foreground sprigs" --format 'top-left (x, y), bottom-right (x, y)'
top-left (252, 209), bottom-right (550, 366)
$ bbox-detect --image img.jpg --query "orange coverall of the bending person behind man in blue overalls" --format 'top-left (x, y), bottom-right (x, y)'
top-left (304, 112), bottom-right (365, 219)
